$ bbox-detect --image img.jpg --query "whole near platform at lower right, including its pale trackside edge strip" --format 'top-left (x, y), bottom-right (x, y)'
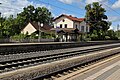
top-left (56, 51), bottom-right (120, 80)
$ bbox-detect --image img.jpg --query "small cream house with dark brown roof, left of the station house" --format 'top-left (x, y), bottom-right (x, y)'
top-left (21, 22), bottom-right (52, 35)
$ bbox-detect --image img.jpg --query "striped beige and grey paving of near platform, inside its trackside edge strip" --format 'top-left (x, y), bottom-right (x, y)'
top-left (65, 56), bottom-right (120, 80)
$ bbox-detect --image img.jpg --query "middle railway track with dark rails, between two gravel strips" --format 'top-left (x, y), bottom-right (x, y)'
top-left (0, 45), bottom-right (120, 77)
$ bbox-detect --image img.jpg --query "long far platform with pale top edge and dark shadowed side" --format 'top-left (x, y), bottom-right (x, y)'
top-left (0, 41), bottom-right (119, 55)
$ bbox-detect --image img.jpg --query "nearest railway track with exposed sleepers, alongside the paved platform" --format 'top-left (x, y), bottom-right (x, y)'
top-left (41, 53), bottom-right (120, 80)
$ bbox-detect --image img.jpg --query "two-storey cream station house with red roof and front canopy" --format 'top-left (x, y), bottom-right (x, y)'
top-left (51, 14), bottom-right (89, 41)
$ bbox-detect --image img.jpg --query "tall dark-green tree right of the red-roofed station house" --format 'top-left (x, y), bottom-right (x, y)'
top-left (85, 2), bottom-right (111, 38)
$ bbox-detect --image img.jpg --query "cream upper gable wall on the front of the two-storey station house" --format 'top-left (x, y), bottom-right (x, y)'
top-left (54, 17), bottom-right (73, 28)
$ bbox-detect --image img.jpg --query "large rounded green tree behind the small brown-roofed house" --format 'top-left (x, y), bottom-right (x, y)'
top-left (17, 5), bottom-right (53, 29)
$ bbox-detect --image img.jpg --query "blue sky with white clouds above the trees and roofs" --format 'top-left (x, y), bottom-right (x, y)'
top-left (0, 0), bottom-right (120, 30)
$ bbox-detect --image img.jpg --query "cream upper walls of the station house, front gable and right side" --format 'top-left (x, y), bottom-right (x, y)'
top-left (54, 16), bottom-right (89, 32)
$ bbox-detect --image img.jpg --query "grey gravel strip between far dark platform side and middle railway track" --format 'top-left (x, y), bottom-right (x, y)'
top-left (0, 44), bottom-right (120, 63)
